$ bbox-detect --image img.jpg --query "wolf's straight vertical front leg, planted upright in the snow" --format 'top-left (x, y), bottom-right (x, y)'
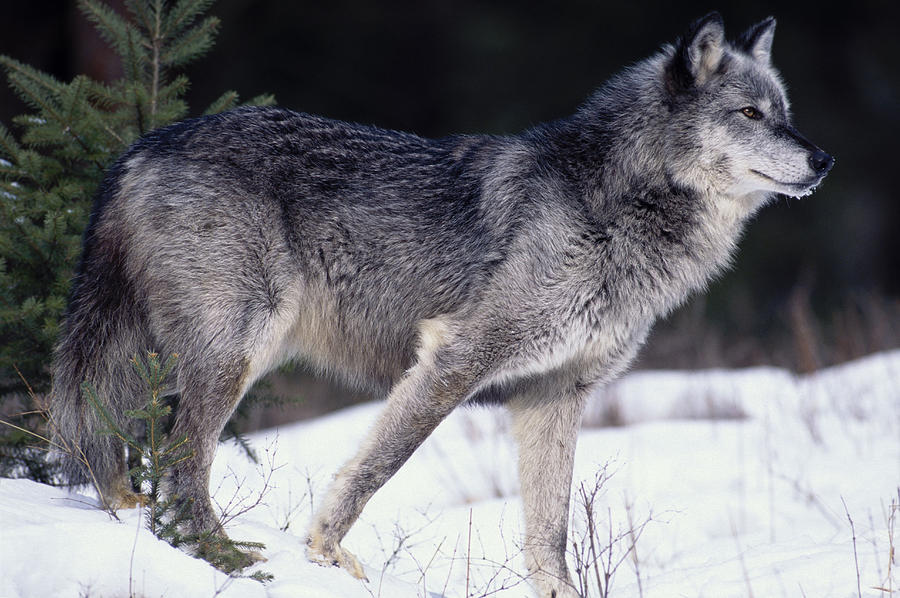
top-left (507, 376), bottom-right (585, 598)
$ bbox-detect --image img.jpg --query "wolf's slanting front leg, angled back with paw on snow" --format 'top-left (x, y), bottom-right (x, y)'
top-left (307, 362), bottom-right (473, 579)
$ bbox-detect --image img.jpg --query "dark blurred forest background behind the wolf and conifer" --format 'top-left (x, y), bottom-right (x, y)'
top-left (0, 0), bottom-right (900, 420)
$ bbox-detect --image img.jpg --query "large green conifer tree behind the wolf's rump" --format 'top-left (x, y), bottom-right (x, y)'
top-left (0, 0), bottom-right (274, 474)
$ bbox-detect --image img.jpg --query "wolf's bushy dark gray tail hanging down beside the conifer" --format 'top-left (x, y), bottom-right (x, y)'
top-left (50, 162), bottom-right (150, 500)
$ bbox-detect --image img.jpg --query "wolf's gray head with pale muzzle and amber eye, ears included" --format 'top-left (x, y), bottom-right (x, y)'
top-left (657, 13), bottom-right (834, 209)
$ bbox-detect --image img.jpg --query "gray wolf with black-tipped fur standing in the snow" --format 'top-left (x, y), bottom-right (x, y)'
top-left (52, 13), bottom-right (833, 598)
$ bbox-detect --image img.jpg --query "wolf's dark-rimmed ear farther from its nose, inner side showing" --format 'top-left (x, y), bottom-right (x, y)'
top-left (669, 12), bottom-right (725, 90)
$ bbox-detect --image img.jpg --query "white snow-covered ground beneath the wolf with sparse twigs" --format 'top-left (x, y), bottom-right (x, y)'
top-left (0, 351), bottom-right (900, 598)
